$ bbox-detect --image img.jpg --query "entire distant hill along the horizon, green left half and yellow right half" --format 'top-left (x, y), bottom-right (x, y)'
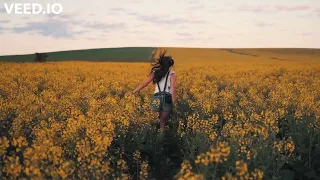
top-left (0, 47), bottom-right (320, 64)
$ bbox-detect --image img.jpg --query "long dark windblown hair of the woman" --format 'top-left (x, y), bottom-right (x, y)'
top-left (151, 50), bottom-right (174, 83)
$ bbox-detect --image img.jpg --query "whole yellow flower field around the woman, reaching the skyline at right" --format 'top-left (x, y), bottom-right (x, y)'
top-left (0, 48), bottom-right (320, 179)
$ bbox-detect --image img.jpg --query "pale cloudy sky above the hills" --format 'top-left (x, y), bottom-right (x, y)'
top-left (0, 0), bottom-right (320, 55)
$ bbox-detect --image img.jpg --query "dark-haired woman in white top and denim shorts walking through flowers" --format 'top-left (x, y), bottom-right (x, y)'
top-left (126, 51), bottom-right (177, 130)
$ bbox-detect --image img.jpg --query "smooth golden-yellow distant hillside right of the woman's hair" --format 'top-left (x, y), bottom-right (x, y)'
top-left (156, 48), bottom-right (320, 64)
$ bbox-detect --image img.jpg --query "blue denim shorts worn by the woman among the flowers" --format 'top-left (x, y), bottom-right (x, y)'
top-left (150, 92), bottom-right (173, 112)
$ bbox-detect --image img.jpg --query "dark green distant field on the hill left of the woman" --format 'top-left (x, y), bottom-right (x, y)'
top-left (0, 47), bottom-right (155, 62)
